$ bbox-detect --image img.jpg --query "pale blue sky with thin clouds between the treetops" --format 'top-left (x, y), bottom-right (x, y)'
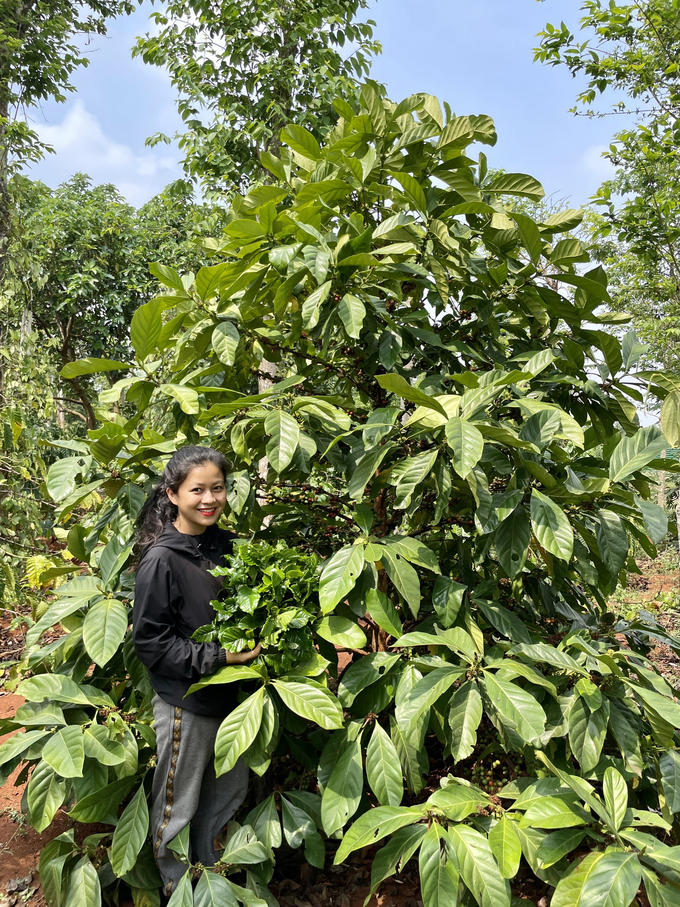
top-left (31, 0), bottom-right (624, 206)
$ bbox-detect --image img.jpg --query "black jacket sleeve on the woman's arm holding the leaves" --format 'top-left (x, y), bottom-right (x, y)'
top-left (132, 557), bottom-right (226, 682)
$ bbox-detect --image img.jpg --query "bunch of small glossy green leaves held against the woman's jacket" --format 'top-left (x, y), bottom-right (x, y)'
top-left (193, 542), bottom-right (319, 674)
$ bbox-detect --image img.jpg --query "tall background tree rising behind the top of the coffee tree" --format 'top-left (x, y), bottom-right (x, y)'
top-left (134, 0), bottom-right (380, 195)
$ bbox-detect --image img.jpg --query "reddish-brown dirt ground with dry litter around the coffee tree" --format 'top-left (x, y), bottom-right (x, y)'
top-left (0, 559), bottom-right (680, 907)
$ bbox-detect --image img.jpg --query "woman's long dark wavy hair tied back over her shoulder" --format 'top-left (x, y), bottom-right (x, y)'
top-left (136, 446), bottom-right (227, 552)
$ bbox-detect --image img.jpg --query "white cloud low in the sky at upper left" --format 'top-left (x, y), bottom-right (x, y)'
top-left (31, 100), bottom-right (180, 205)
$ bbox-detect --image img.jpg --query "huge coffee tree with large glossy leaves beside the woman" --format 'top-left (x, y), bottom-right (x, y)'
top-left (0, 83), bottom-right (680, 907)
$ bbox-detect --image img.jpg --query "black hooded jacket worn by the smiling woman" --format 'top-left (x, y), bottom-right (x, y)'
top-left (132, 523), bottom-right (237, 718)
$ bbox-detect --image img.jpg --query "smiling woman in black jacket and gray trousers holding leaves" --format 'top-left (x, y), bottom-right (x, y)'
top-left (133, 447), bottom-right (260, 895)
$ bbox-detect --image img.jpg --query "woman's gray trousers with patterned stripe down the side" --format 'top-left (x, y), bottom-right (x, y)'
top-left (151, 696), bottom-right (248, 894)
